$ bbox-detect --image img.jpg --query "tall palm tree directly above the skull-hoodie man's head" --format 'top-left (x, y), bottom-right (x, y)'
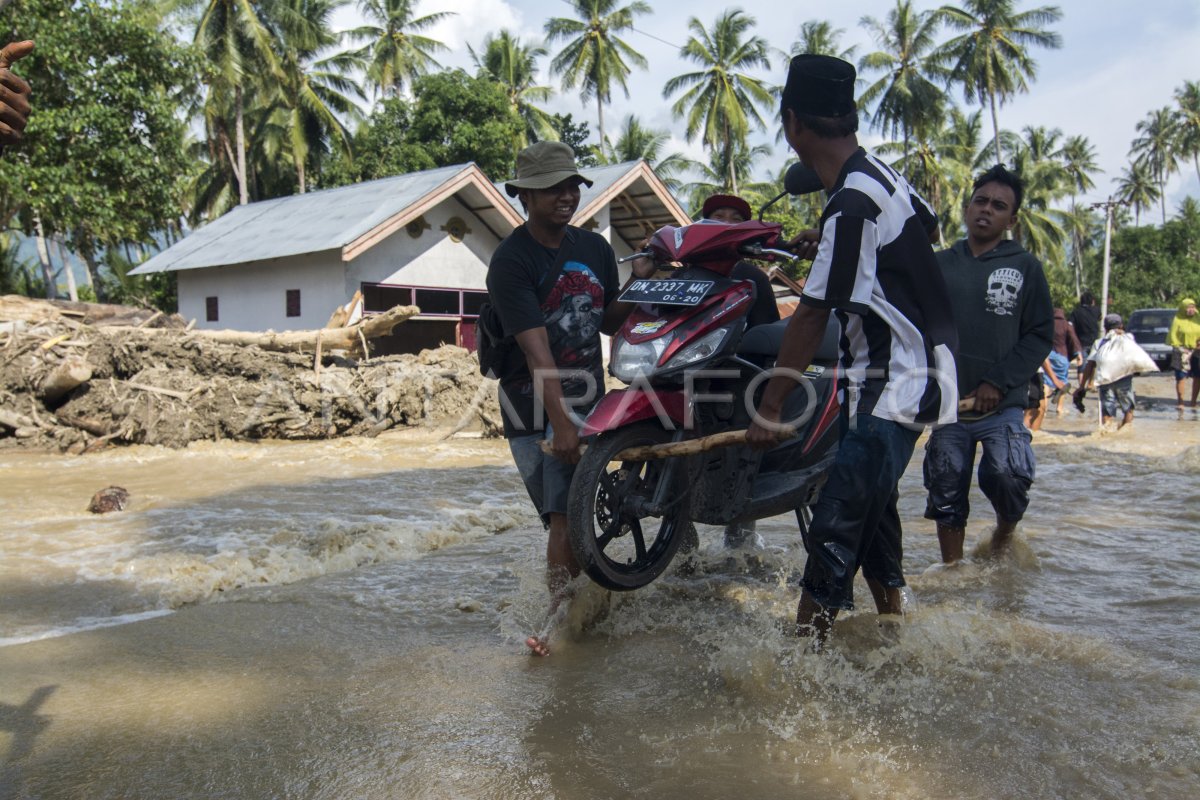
top-left (936, 0), bottom-right (1062, 163)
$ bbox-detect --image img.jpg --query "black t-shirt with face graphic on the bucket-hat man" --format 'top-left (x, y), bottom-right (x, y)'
top-left (487, 225), bottom-right (619, 438)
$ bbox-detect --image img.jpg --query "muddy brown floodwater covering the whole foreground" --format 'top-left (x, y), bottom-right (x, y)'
top-left (0, 378), bottom-right (1200, 800)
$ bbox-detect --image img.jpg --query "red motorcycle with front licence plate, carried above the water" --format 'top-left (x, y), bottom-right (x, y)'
top-left (568, 166), bottom-right (841, 590)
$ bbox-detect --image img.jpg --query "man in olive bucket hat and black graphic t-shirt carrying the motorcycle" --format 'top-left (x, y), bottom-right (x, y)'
top-left (487, 142), bottom-right (654, 655)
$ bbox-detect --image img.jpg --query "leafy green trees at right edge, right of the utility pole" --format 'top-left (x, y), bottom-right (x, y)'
top-left (1090, 213), bottom-right (1200, 315)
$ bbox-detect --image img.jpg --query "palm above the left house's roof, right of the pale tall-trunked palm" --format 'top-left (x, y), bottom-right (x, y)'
top-left (272, 0), bottom-right (365, 194)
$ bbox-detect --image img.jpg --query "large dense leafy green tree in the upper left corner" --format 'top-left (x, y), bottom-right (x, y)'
top-left (0, 0), bottom-right (199, 299)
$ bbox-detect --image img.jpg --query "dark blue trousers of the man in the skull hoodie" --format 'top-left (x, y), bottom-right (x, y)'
top-left (924, 408), bottom-right (1036, 528)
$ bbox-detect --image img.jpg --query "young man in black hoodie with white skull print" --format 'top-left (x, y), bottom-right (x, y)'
top-left (924, 167), bottom-right (1054, 564)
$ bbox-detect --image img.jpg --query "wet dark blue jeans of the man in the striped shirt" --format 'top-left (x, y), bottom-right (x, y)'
top-left (803, 414), bottom-right (920, 608)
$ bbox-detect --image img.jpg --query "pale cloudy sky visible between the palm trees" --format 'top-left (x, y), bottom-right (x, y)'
top-left (337, 0), bottom-right (1200, 207)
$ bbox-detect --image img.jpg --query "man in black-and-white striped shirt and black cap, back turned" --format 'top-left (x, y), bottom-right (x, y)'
top-left (749, 55), bottom-right (958, 638)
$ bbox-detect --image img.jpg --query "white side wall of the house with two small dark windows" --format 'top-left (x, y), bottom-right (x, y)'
top-left (178, 251), bottom-right (349, 331)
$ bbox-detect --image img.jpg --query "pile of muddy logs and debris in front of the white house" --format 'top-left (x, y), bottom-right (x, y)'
top-left (0, 295), bottom-right (500, 453)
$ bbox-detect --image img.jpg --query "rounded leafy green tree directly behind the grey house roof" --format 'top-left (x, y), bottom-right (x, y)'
top-left (323, 70), bottom-right (524, 186)
